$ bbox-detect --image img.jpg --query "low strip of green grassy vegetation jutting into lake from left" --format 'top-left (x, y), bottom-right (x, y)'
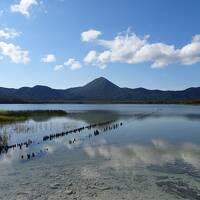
top-left (0, 110), bottom-right (67, 123)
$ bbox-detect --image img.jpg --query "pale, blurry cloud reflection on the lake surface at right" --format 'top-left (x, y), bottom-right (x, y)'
top-left (84, 139), bottom-right (200, 169)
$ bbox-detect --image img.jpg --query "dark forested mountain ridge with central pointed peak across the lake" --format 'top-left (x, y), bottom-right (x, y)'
top-left (0, 77), bottom-right (200, 103)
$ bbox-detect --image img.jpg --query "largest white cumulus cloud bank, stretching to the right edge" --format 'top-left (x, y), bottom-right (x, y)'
top-left (84, 30), bottom-right (200, 68)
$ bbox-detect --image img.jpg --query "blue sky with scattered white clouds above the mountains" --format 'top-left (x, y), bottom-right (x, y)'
top-left (0, 0), bottom-right (200, 90)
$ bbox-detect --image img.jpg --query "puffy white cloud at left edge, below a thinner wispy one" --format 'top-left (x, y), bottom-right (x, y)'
top-left (0, 42), bottom-right (30, 64)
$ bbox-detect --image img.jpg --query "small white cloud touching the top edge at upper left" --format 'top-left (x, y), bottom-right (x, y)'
top-left (10, 0), bottom-right (38, 17)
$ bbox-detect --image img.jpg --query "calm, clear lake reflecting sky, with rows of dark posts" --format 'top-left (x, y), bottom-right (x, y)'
top-left (0, 104), bottom-right (200, 200)
